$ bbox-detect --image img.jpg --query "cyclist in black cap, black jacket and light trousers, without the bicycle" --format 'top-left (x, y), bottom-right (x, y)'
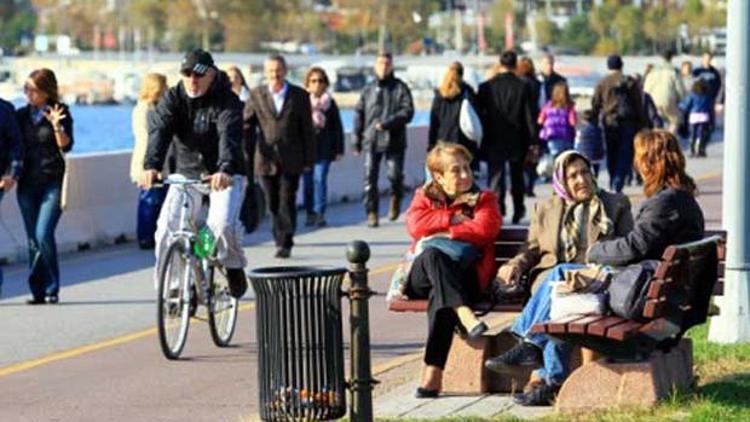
top-left (139, 49), bottom-right (247, 298)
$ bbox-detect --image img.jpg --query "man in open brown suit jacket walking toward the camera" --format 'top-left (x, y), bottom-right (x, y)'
top-left (244, 55), bottom-right (315, 258)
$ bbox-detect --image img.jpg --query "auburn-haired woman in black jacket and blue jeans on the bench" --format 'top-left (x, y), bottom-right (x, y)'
top-left (485, 129), bottom-right (704, 405)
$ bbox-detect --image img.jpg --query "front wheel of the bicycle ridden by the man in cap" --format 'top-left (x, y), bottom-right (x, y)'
top-left (156, 241), bottom-right (190, 360)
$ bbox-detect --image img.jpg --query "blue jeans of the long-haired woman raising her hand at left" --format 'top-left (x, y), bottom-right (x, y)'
top-left (17, 181), bottom-right (62, 299)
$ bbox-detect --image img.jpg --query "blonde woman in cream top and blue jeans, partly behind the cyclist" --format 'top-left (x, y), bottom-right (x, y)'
top-left (130, 73), bottom-right (167, 249)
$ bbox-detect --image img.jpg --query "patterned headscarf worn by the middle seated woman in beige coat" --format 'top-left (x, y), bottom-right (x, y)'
top-left (552, 151), bottom-right (614, 262)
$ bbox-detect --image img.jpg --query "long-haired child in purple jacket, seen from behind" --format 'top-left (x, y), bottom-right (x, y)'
top-left (538, 82), bottom-right (576, 157)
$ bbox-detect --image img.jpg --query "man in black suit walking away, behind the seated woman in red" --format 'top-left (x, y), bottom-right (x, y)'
top-left (477, 51), bottom-right (536, 224)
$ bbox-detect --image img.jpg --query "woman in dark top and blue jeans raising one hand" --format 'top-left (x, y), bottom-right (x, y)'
top-left (16, 69), bottom-right (73, 305)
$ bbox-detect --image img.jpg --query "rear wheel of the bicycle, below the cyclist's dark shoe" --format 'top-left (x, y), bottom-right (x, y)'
top-left (208, 265), bottom-right (239, 347)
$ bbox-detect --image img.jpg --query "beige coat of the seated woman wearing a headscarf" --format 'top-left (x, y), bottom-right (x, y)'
top-left (508, 191), bottom-right (633, 286)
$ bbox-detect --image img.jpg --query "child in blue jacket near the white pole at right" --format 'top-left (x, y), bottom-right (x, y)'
top-left (680, 79), bottom-right (713, 157)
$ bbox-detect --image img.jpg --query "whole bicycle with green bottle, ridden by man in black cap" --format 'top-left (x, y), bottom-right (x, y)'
top-left (157, 175), bottom-right (239, 360)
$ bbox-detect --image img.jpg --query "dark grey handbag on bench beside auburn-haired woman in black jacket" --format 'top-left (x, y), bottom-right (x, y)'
top-left (609, 259), bottom-right (661, 321)
